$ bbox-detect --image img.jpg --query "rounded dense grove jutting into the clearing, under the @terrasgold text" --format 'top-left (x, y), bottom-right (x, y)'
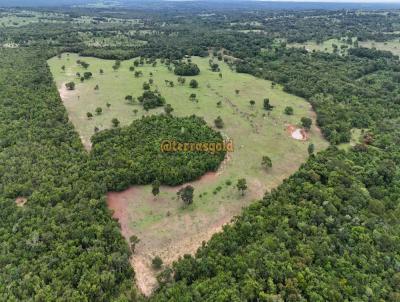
top-left (90, 115), bottom-right (225, 191)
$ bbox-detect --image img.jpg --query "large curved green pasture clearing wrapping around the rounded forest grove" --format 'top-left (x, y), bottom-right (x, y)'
top-left (48, 54), bottom-right (328, 293)
